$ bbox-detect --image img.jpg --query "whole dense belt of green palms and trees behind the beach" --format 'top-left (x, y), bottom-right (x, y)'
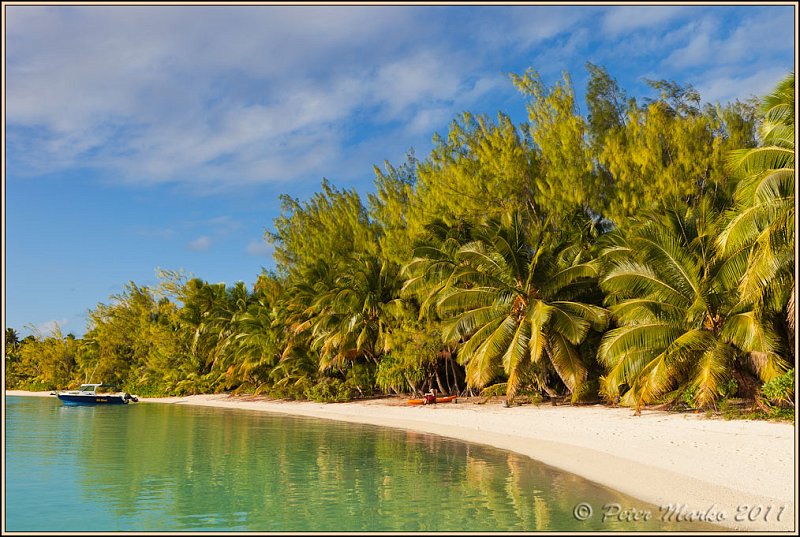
top-left (6, 64), bottom-right (795, 409)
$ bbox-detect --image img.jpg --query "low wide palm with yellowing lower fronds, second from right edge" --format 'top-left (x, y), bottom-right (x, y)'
top-left (598, 200), bottom-right (787, 412)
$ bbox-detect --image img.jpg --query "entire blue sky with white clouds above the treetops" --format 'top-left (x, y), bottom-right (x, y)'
top-left (3, 3), bottom-right (797, 337)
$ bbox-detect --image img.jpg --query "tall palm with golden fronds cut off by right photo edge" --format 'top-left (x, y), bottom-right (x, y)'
top-left (718, 73), bottom-right (796, 337)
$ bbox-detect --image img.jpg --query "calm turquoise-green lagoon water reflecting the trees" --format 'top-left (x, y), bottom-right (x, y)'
top-left (5, 396), bottom-right (711, 532)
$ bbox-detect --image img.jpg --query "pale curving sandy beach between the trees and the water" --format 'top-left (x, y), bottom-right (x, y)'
top-left (6, 391), bottom-right (797, 531)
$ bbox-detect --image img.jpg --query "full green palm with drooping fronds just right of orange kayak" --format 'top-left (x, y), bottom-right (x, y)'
top-left (405, 215), bottom-right (606, 401)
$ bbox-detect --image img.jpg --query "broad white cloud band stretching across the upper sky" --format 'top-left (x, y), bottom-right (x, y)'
top-left (6, 5), bottom-right (791, 193)
